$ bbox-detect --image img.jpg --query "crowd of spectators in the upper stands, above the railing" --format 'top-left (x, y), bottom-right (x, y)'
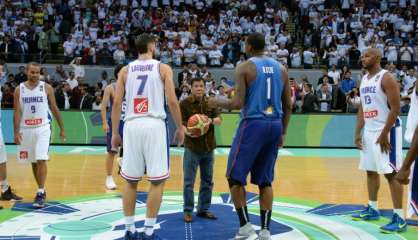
top-left (0, 0), bottom-right (418, 68)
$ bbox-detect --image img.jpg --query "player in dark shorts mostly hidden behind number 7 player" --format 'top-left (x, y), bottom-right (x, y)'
top-left (100, 65), bottom-right (125, 190)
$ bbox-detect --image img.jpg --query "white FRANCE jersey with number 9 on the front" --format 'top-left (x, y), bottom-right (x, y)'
top-left (19, 81), bottom-right (50, 128)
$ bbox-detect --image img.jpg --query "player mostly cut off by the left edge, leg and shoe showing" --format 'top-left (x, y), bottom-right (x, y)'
top-left (0, 66), bottom-right (22, 209)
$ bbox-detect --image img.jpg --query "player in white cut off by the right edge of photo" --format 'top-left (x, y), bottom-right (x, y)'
top-left (396, 83), bottom-right (418, 217)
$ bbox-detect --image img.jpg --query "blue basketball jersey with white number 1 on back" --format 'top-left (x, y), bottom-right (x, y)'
top-left (241, 57), bottom-right (283, 119)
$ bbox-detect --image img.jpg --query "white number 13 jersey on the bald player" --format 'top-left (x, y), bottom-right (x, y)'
top-left (360, 69), bottom-right (390, 131)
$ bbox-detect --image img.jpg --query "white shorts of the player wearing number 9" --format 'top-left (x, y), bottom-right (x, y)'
top-left (17, 124), bottom-right (51, 163)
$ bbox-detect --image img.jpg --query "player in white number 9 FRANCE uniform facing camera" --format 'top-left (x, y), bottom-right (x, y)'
top-left (13, 62), bottom-right (65, 208)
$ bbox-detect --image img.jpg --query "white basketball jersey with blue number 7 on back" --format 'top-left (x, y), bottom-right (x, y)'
top-left (125, 59), bottom-right (166, 121)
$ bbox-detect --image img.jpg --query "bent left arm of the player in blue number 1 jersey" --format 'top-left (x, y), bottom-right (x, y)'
top-left (209, 61), bottom-right (247, 110)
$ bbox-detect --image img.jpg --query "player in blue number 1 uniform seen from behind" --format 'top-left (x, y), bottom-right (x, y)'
top-left (209, 33), bottom-right (292, 240)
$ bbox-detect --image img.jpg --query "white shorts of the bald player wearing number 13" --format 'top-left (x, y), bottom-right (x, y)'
top-left (359, 126), bottom-right (403, 174)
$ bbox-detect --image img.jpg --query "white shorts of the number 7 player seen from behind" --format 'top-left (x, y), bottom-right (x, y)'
top-left (121, 117), bottom-right (170, 181)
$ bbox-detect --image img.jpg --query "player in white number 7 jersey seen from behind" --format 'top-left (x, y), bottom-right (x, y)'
top-left (112, 34), bottom-right (184, 239)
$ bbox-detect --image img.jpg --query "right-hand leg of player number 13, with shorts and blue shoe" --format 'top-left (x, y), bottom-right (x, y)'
top-left (379, 126), bottom-right (407, 233)
